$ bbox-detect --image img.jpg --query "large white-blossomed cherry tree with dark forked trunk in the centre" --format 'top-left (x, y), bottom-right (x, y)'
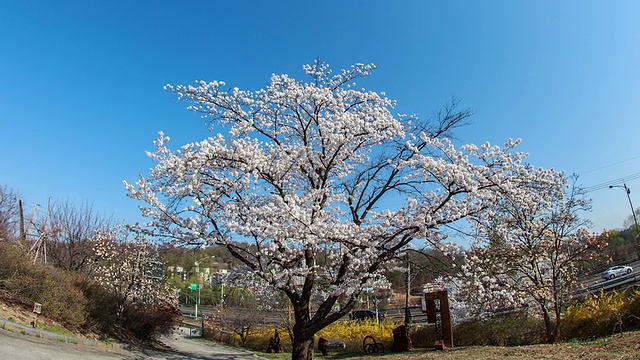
top-left (125, 61), bottom-right (558, 359)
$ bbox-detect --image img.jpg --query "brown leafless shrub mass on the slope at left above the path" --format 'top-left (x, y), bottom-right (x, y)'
top-left (0, 243), bottom-right (178, 343)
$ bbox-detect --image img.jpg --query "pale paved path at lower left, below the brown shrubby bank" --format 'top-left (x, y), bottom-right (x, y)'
top-left (0, 329), bottom-right (262, 360)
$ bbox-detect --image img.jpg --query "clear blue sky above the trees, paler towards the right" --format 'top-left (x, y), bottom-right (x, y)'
top-left (0, 0), bottom-right (640, 231)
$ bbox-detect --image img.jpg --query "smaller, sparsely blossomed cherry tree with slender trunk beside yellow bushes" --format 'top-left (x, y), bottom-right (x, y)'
top-left (461, 178), bottom-right (607, 343)
